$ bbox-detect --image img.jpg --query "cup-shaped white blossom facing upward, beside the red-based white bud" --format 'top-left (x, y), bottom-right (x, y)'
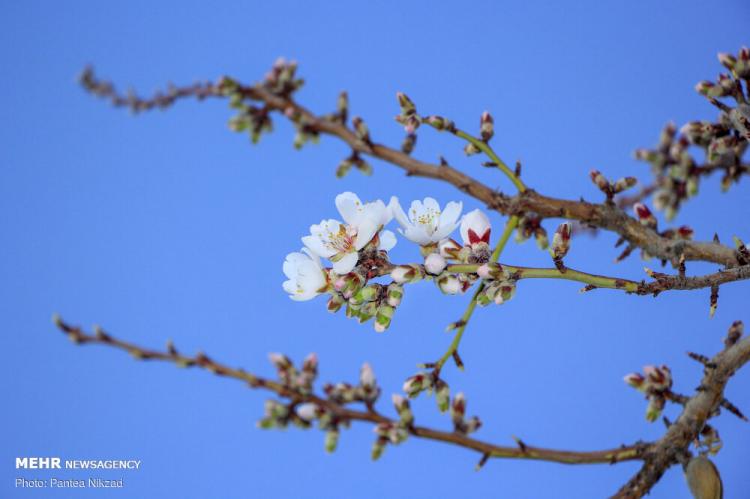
top-left (388, 196), bottom-right (463, 246)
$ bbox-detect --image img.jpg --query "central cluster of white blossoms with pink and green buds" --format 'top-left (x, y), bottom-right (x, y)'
top-left (283, 192), bottom-right (506, 332)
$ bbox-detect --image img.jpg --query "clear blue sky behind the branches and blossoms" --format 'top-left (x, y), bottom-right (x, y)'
top-left (0, 1), bottom-right (750, 499)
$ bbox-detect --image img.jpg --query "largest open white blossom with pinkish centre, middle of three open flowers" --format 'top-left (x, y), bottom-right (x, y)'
top-left (302, 192), bottom-right (395, 275)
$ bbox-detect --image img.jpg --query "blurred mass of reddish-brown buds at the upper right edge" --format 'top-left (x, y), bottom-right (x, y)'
top-left (635, 47), bottom-right (750, 220)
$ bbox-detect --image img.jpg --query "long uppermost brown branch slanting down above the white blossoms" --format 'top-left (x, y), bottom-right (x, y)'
top-left (81, 69), bottom-right (748, 267)
